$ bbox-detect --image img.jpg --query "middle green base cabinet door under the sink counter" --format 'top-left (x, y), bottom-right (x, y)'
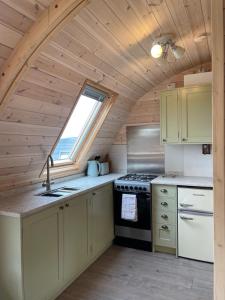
top-left (63, 195), bottom-right (88, 283)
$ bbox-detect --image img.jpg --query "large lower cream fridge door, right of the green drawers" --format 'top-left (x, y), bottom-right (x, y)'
top-left (178, 211), bottom-right (214, 262)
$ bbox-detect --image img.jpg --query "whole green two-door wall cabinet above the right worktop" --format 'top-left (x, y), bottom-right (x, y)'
top-left (160, 86), bottom-right (212, 144)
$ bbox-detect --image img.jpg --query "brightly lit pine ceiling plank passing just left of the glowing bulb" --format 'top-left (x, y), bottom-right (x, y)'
top-left (105, 0), bottom-right (169, 81)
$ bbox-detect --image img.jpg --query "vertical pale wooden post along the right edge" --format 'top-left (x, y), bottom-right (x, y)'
top-left (212, 0), bottom-right (225, 300)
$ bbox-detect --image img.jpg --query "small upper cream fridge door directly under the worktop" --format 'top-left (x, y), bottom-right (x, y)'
top-left (178, 188), bottom-right (213, 212)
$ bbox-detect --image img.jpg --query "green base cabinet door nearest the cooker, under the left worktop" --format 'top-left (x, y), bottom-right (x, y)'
top-left (90, 184), bottom-right (114, 257)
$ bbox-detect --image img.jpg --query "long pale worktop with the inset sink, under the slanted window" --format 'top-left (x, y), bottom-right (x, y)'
top-left (0, 173), bottom-right (123, 217)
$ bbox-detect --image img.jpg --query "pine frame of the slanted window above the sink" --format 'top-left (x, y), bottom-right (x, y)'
top-left (40, 80), bottom-right (118, 178)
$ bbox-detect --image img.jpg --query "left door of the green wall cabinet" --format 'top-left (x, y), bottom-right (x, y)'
top-left (160, 89), bottom-right (180, 144)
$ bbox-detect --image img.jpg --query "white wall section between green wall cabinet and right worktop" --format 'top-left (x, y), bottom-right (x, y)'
top-left (165, 145), bottom-right (213, 177)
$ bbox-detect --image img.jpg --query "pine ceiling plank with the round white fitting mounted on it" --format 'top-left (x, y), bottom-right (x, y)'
top-left (184, 0), bottom-right (211, 62)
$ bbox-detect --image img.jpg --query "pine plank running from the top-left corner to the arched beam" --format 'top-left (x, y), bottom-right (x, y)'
top-left (1, 0), bottom-right (43, 21)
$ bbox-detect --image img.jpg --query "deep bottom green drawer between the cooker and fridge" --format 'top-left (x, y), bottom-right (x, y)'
top-left (153, 224), bottom-right (176, 248)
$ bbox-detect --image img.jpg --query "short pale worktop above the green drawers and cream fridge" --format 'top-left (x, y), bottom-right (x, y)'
top-left (151, 176), bottom-right (213, 188)
